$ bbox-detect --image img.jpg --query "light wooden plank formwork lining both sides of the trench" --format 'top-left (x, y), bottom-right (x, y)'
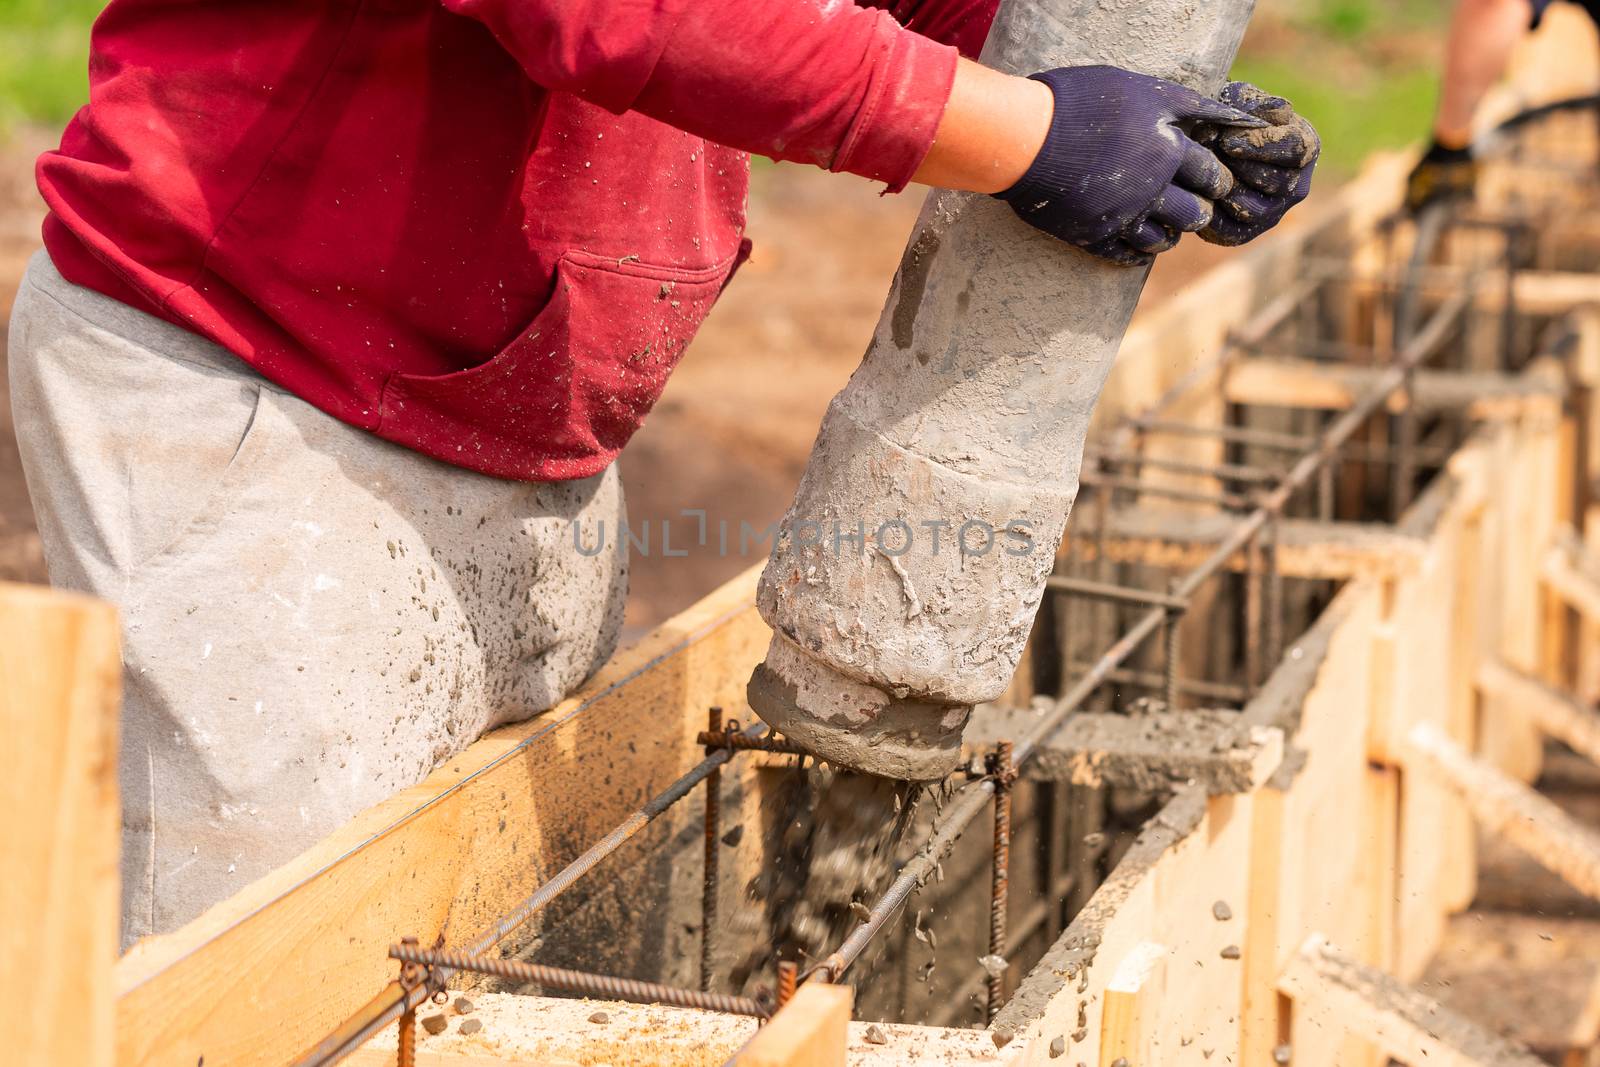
top-left (15, 16), bottom-right (1600, 1067)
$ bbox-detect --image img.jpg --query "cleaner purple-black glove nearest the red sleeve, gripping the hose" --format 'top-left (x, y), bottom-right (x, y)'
top-left (995, 67), bottom-right (1267, 266)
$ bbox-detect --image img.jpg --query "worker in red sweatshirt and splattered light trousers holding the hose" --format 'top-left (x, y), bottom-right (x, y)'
top-left (10, 0), bottom-right (1317, 941)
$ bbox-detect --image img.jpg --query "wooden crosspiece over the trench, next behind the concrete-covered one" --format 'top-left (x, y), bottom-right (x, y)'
top-left (1062, 507), bottom-right (1427, 581)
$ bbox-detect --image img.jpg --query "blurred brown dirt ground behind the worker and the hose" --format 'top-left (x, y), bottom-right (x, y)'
top-left (0, 130), bottom-right (1227, 635)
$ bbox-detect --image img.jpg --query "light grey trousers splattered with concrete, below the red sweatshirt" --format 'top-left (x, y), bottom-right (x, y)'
top-left (10, 254), bottom-right (627, 944)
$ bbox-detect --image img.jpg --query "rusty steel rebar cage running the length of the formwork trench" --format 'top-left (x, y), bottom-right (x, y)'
top-left (301, 163), bottom-right (1568, 1065)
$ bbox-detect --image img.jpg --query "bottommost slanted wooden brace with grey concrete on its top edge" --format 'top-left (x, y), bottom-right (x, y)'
top-left (1278, 934), bottom-right (1544, 1067)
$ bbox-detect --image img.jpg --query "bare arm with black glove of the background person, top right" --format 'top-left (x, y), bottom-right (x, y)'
top-left (1406, 0), bottom-right (1600, 211)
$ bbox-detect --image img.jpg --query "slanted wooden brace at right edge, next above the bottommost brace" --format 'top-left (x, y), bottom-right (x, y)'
top-left (1408, 723), bottom-right (1600, 899)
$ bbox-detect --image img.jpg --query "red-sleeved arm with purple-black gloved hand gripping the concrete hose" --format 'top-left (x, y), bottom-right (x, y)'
top-left (442, 0), bottom-right (1315, 262)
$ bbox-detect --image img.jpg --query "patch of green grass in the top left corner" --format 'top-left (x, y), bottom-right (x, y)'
top-left (0, 0), bottom-right (106, 128)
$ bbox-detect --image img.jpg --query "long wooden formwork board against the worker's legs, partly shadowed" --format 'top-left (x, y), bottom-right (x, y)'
top-left (115, 566), bottom-right (770, 1067)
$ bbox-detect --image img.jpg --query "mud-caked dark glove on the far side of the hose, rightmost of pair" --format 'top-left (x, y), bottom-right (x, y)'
top-left (1195, 82), bottom-right (1322, 245)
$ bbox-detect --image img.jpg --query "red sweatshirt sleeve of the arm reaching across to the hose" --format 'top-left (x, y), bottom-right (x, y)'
top-left (442, 0), bottom-right (957, 190)
